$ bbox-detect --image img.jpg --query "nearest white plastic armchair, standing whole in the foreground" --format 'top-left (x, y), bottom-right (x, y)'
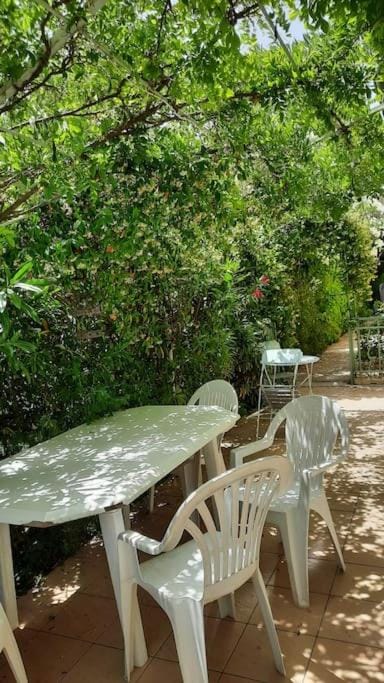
top-left (119, 456), bottom-right (292, 683)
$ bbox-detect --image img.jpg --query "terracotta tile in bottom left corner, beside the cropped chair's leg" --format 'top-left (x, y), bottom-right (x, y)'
top-left (0, 629), bottom-right (90, 683)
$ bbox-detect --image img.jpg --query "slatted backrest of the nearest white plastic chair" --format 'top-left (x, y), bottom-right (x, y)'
top-left (162, 456), bottom-right (292, 590)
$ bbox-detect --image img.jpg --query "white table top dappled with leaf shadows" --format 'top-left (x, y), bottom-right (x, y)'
top-left (0, 406), bottom-right (238, 524)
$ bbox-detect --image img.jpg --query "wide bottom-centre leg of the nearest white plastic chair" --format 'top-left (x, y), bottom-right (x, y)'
top-left (167, 598), bottom-right (208, 683)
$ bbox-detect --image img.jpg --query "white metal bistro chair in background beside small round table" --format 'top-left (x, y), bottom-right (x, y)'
top-left (256, 348), bottom-right (303, 438)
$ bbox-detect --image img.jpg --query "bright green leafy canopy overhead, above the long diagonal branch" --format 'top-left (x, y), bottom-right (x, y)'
top-left (0, 0), bottom-right (382, 226)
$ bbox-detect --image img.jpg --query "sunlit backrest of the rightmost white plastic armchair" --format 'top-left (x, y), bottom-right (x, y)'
top-left (266, 395), bottom-right (349, 490)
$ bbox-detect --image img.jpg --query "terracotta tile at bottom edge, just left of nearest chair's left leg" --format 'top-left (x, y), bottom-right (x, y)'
top-left (63, 645), bottom-right (145, 683)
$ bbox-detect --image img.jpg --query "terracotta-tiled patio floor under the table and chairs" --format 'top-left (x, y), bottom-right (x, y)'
top-left (0, 340), bottom-right (384, 683)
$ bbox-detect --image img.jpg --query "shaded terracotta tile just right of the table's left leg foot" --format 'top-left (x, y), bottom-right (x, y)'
top-left (21, 593), bottom-right (117, 642)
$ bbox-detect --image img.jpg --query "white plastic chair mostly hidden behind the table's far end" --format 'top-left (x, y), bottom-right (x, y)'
top-left (148, 379), bottom-right (239, 512)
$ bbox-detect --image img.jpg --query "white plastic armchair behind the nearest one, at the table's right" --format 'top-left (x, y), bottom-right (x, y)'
top-left (231, 395), bottom-right (349, 607)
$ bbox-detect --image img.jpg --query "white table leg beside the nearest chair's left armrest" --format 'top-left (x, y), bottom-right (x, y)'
top-left (99, 509), bottom-right (148, 666)
